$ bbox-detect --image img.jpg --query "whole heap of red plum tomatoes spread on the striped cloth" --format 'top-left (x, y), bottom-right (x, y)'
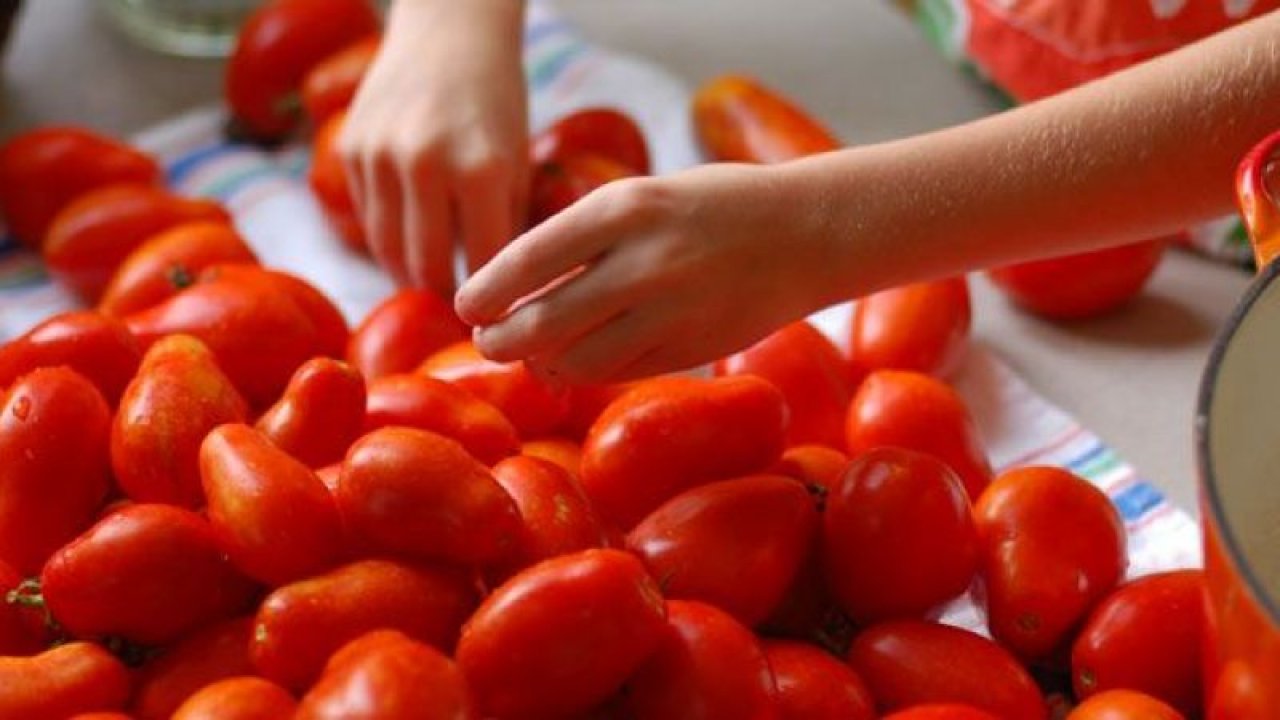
top-left (0, 0), bottom-right (1204, 720)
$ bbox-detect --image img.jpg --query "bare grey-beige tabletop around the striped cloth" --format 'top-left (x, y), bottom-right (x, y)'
top-left (0, 0), bottom-right (1249, 511)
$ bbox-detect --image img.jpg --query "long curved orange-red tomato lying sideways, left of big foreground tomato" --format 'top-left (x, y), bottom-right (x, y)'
top-left (250, 560), bottom-right (476, 691)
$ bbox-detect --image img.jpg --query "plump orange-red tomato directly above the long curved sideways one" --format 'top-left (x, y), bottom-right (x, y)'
top-left (337, 427), bottom-right (524, 565)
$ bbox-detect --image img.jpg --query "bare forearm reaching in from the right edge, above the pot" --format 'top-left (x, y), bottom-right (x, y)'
top-left (780, 13), bottom-right (1280, 300)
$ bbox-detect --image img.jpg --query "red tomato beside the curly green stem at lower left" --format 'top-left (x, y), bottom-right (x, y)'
top-left (40, 503), bottom-right (255, 644)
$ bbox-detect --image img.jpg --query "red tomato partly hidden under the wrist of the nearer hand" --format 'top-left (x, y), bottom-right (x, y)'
top-left (714, 320), bottom-right (851, 447)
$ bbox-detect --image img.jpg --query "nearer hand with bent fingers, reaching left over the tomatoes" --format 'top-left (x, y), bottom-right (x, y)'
top-left (457, 165), bottom-right (838, 382)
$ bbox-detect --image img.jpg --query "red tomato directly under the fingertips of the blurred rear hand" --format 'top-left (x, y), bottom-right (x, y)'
top-left (347, 288), bottom-right (471, 380)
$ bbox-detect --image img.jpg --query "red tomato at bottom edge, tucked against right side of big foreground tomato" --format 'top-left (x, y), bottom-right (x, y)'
top-left (627, 600), bottom-right (781, 720)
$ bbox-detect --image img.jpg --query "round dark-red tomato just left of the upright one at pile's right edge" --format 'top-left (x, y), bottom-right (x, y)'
top-left (822, 447), bottom-right (978, 624)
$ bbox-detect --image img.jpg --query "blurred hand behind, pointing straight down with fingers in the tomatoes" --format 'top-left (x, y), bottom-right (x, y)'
top-left (338, 0), bottom-right (529, 297)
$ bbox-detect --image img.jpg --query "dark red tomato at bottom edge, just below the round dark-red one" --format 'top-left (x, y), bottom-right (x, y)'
top-left (849, 620), bottom-right (1047, 720)
